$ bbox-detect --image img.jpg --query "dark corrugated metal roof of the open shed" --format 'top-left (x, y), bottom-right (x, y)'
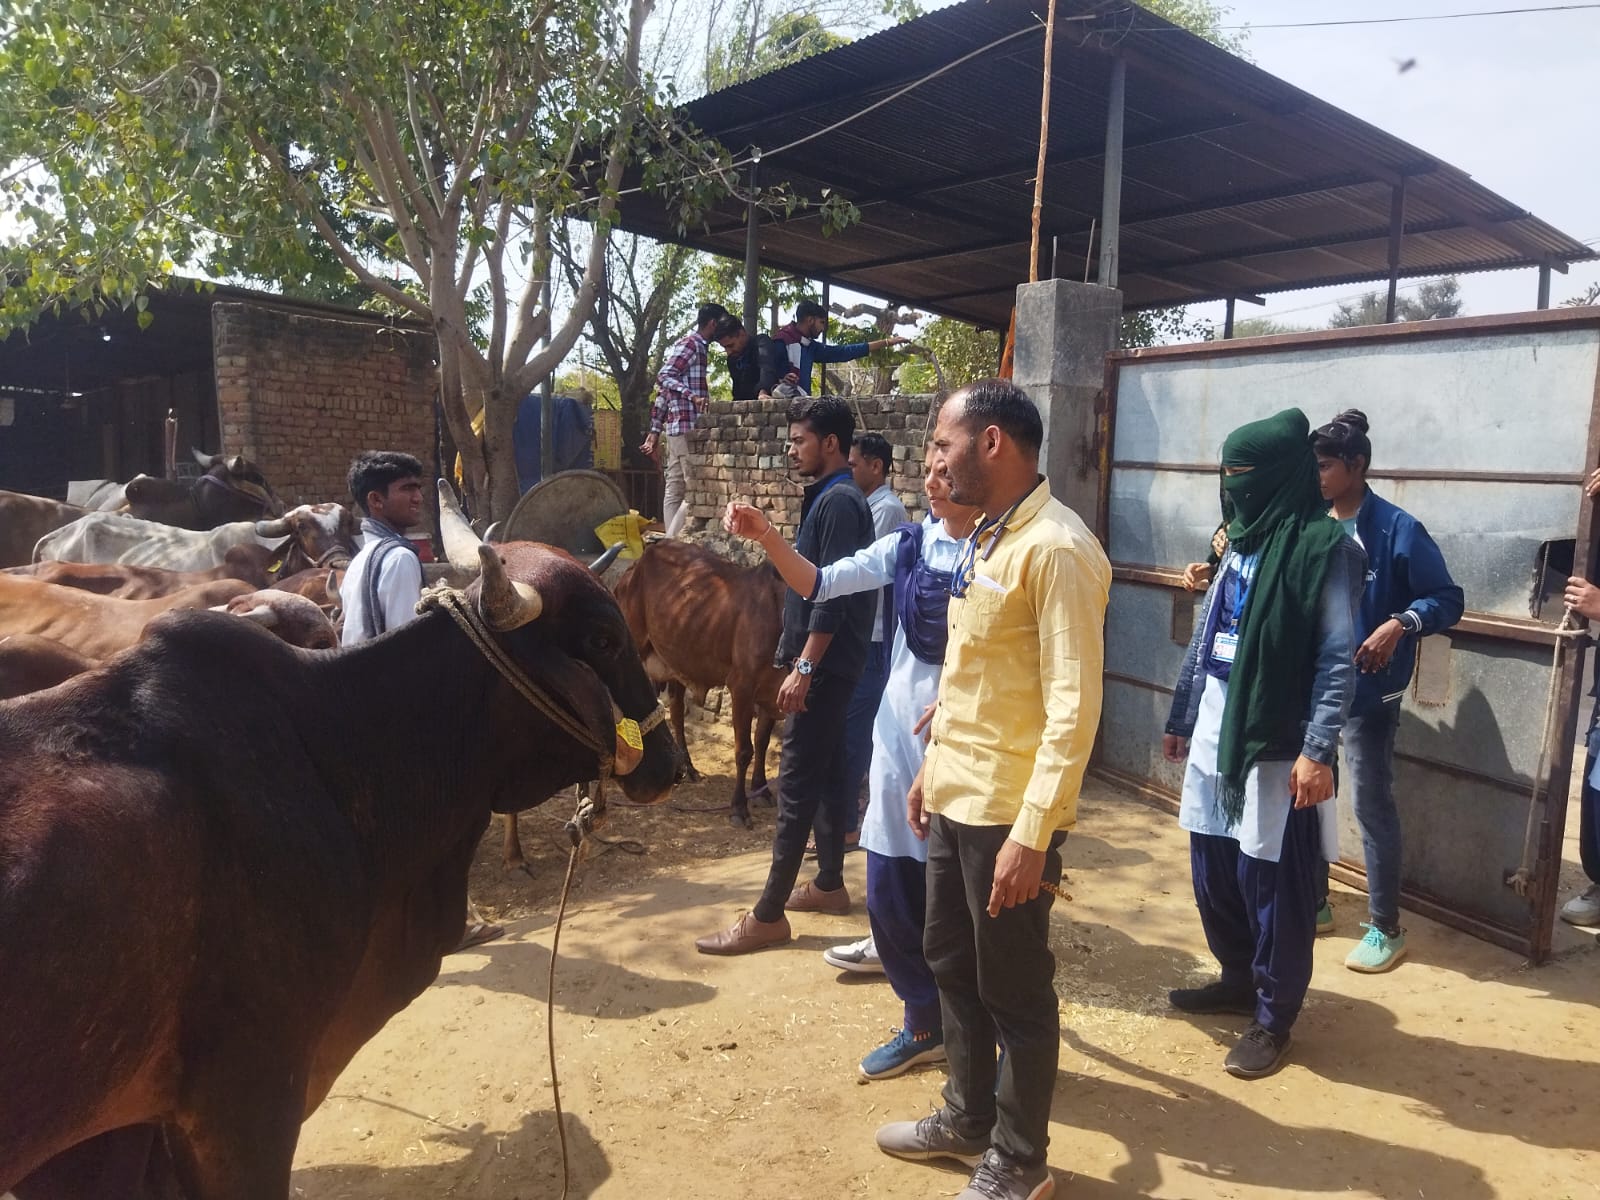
top-left (621, 0), bottom-right (1595, 326)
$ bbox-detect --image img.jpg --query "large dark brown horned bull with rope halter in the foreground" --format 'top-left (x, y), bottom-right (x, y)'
top-left (0, 542), bottom-right (677, 1200)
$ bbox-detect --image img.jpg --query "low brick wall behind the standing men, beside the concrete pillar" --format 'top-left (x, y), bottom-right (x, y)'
top-left (688, 395), bottom-right (931, 538)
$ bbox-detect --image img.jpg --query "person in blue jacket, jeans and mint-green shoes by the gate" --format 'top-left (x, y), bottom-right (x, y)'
top-left (1312, 408), bottom-right (1466, 974)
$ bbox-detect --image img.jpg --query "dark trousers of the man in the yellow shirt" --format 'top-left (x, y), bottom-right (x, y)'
top-left (923, 814), bottom-right (1067, 1166)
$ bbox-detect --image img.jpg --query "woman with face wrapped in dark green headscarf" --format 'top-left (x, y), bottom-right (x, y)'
top-left (1162, 408), bottom-right (1366, 1078)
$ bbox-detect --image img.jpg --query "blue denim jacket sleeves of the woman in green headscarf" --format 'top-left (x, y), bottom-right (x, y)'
top-left (1166, 538), bottom-right (1366, 765)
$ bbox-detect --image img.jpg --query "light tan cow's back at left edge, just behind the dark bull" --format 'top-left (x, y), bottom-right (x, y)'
top-left (0, 576), bottom-right (256, 659)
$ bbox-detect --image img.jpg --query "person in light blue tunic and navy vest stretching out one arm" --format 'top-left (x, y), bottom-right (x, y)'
top-left (722, 451), bottom-right (978, 1080)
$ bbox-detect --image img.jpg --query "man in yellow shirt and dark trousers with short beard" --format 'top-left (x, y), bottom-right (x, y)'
top-left (877, 379), bottom-right (1110, 1200)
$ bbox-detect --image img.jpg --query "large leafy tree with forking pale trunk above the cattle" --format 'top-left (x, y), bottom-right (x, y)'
top-left (0, 0), bottom-right (745, 518)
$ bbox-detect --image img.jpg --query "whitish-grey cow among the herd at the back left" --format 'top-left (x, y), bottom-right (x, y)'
top-left (34, 504), bottom-right (355, 574)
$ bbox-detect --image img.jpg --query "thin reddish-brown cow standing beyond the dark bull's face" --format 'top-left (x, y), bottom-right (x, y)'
top-left (616, 539), bottom-right (784, 829)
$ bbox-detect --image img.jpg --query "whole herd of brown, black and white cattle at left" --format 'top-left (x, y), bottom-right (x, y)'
top-left (0, 456), bottom-right (796, 1200)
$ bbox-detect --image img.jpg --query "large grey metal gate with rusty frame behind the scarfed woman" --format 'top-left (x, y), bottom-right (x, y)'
top-left (1096, 309), bottom-right (1600, 962)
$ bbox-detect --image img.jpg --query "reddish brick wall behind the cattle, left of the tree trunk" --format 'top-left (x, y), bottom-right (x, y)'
top-left (211, 302), bottom-right (437, 507)
